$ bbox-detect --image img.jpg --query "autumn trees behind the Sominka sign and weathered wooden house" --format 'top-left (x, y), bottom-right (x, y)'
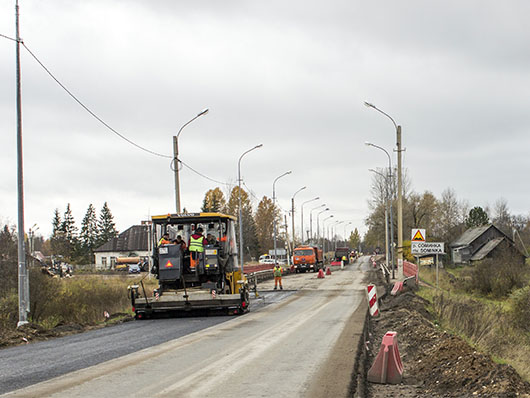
top-left (363, 168), bottom-right (530, 255)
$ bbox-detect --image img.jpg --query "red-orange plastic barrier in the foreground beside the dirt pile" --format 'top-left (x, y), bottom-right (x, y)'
top-left (368, 332), bottom-right (403, 384)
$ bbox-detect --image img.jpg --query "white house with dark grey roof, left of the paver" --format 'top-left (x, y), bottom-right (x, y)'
top-left (94, 225), bottom-right (150, 269)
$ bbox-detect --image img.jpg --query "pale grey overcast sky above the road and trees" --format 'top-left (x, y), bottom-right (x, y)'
top-left (0, 0), bottom-right (530, 236)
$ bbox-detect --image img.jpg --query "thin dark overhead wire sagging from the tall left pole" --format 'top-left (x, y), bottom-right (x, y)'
top-left (0, 33), bottom-right (230, 185)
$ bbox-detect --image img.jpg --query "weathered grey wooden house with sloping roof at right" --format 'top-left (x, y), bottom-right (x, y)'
top-left (449, 224), bottom-right (525, 265)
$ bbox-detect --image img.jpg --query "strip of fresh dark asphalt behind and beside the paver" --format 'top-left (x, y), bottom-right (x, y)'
top-left (0, 291), bottom-right (294, 394)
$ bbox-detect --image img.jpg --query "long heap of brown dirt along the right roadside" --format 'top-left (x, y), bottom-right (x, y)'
top-left (367, 292), bottom-right (530, 398)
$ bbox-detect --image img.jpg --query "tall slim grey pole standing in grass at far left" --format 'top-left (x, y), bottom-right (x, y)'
top-left (15, 0), bottom-right (30, 327)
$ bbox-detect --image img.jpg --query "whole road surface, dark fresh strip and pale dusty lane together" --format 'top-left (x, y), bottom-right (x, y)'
top-left (0, 261), bottom-right (365, 397)
